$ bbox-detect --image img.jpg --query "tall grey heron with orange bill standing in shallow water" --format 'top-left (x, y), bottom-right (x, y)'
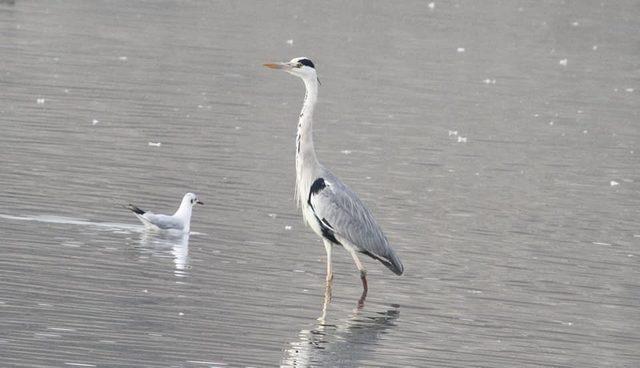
top-left (264, 57), bottom-right (404, 304)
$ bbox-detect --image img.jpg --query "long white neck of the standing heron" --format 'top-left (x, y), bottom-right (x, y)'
top-left (296, 78), bottom-right (319, 205)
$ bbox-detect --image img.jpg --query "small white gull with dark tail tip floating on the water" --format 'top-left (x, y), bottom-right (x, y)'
top-left (126, 193), bottom-right (204, 233)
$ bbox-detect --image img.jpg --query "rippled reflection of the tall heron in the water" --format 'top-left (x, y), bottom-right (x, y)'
top-left (280, 294), bottom-right (400, 367)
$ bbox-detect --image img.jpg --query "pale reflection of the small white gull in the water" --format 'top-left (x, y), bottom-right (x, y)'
top-left (140, 231), bottom-right (189, 277)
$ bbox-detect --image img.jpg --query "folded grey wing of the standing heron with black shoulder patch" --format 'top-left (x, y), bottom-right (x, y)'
top-left (308, 175), bottom-right (404, 275)
